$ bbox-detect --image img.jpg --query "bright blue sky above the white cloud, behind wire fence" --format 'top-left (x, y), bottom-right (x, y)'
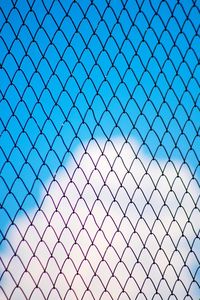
top-left (0, 0), bottom-right (200, 290)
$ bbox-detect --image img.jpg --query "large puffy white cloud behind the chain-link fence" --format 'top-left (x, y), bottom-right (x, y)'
top-left (0, 139), bottom-right (200, 300)
